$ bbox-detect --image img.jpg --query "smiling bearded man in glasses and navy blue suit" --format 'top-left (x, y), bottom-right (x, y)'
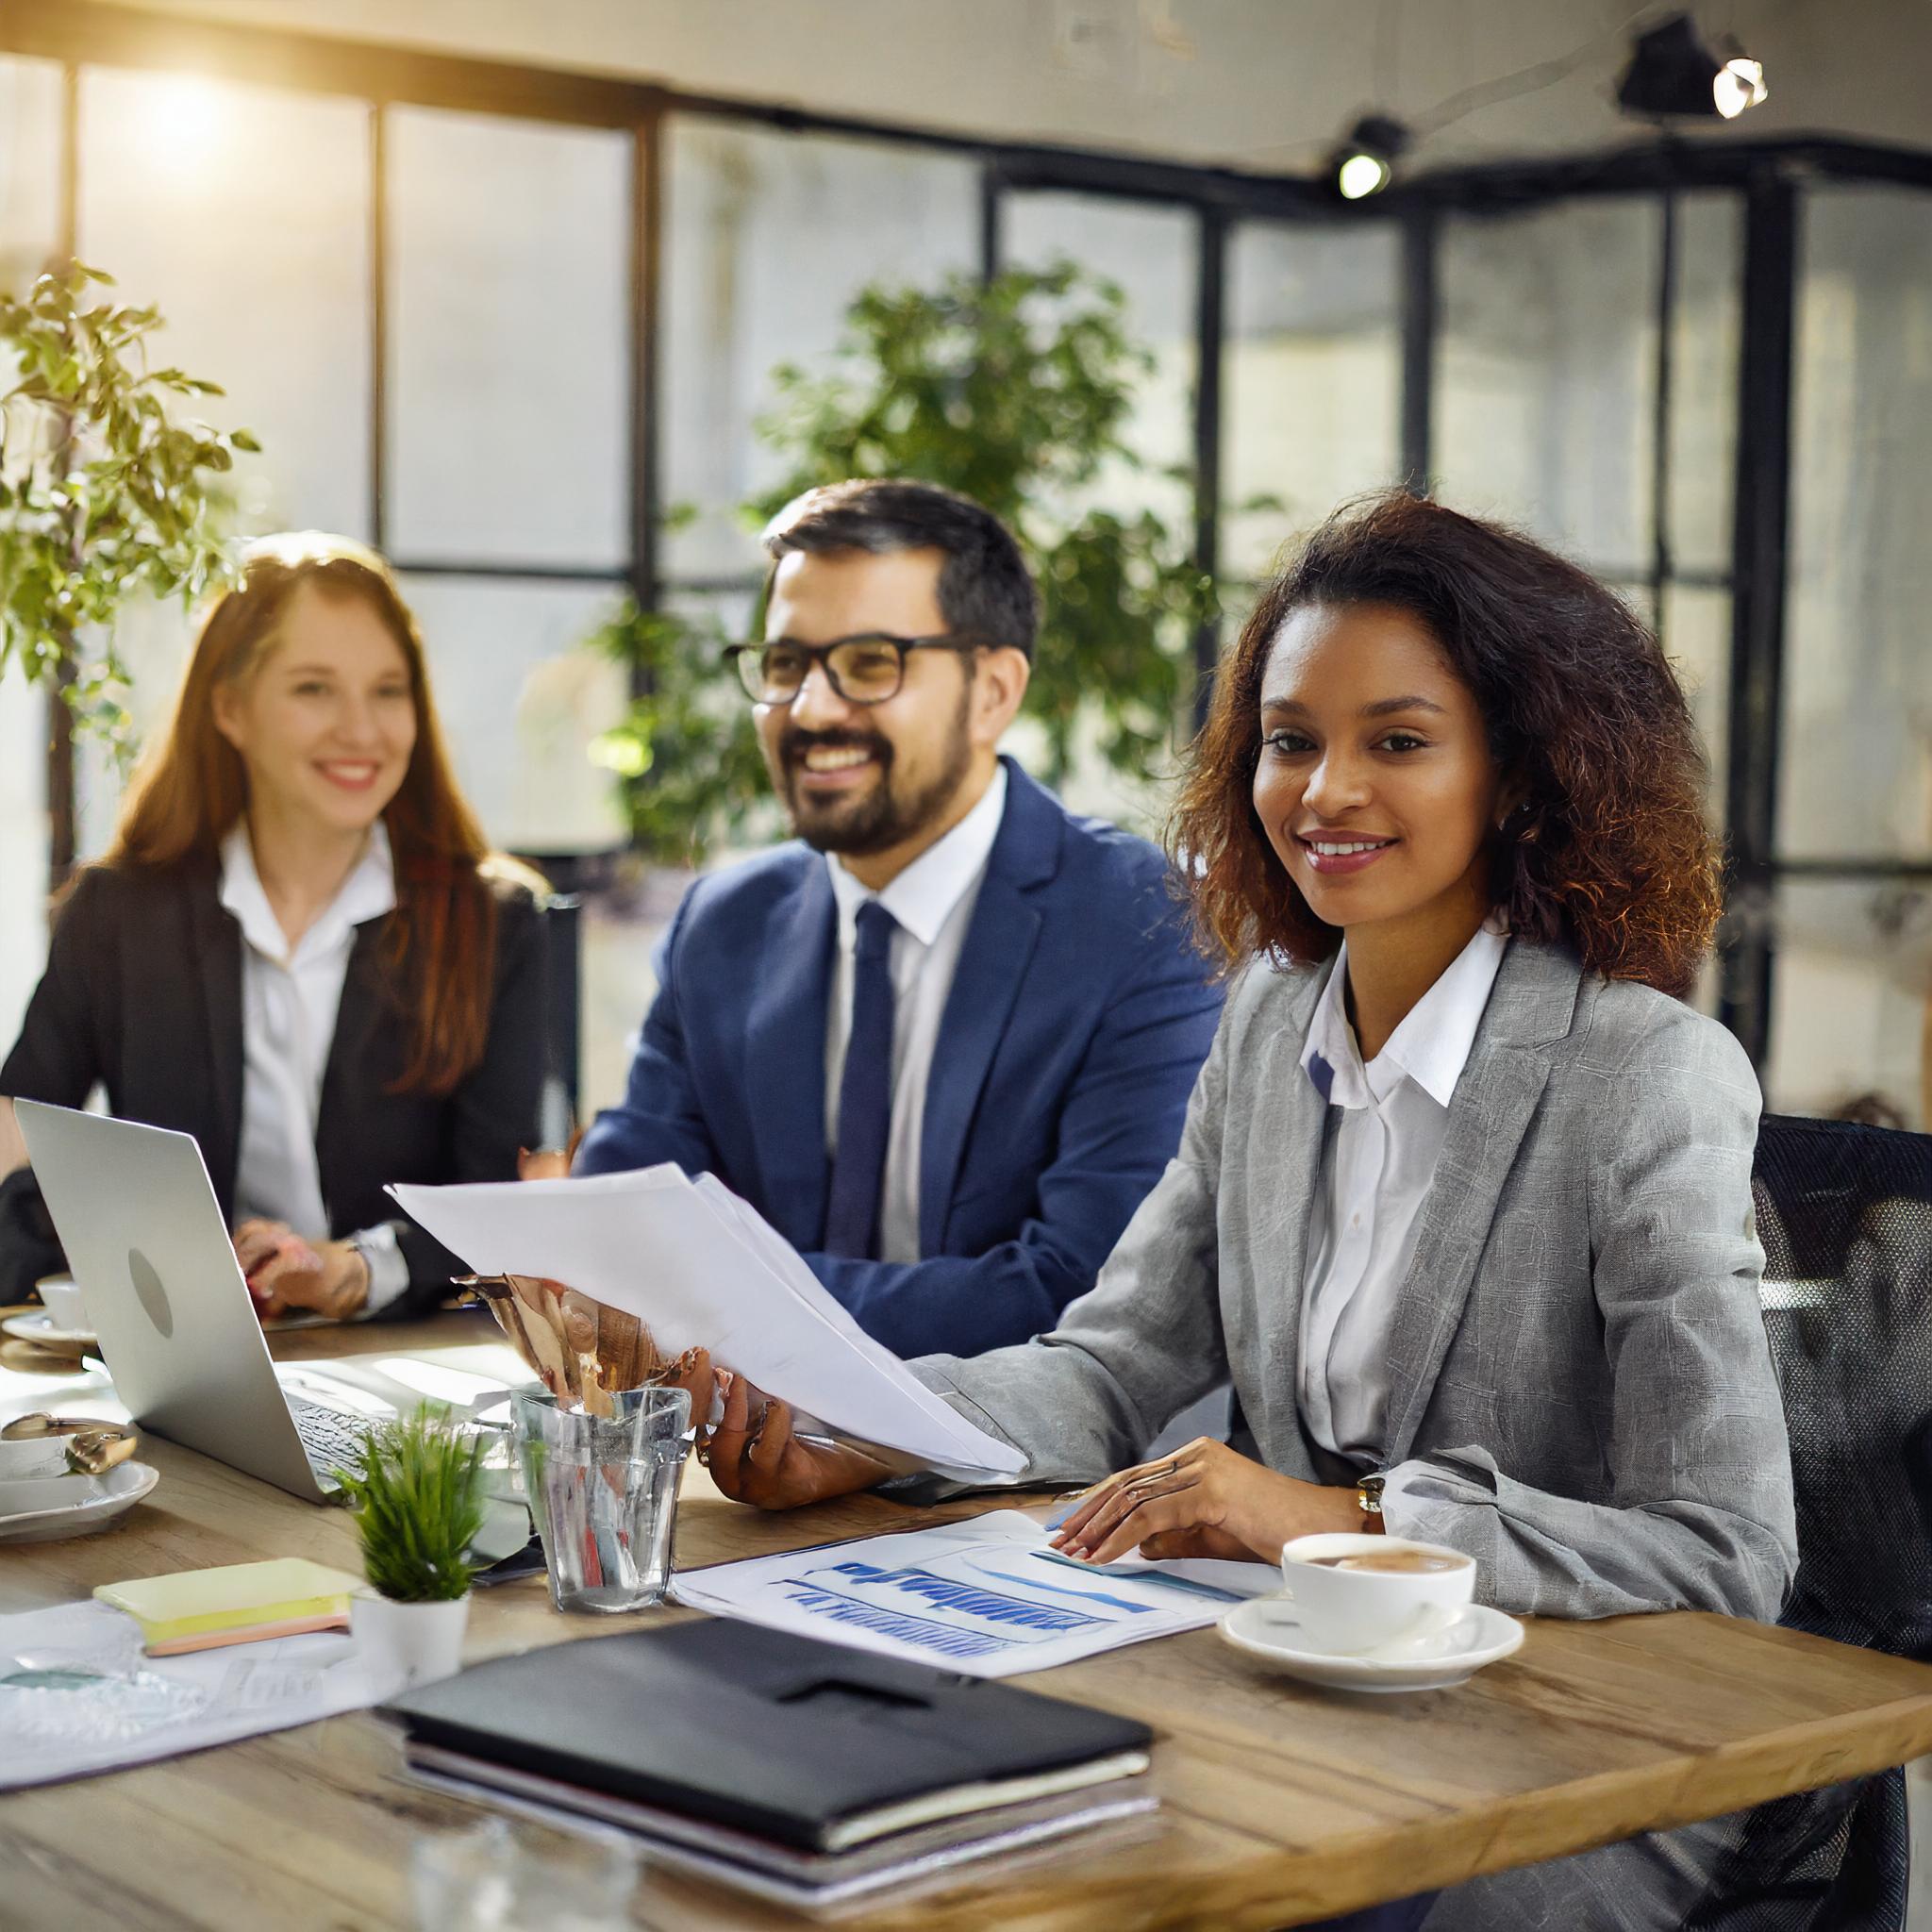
top-left (574, 481), bottom-right (1221, 1357)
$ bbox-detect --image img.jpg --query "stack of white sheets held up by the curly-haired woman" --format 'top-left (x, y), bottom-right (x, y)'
top-left (389, 1165), bottom-right (1025, 1476)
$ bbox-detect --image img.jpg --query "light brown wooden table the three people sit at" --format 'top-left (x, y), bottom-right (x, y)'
top-left (0, 1316), bottom-right (1932, 1932)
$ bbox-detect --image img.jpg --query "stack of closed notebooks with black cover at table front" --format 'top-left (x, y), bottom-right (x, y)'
top-left (387, 1621), bottom-right (1158, 1910)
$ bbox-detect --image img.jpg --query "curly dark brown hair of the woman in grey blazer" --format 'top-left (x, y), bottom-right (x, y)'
top-left (1169, 491), bottom-right (1722, 997)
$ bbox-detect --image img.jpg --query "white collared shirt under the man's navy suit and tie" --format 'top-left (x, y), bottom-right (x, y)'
top-left (824, 765), bottom-right (1007, 1261)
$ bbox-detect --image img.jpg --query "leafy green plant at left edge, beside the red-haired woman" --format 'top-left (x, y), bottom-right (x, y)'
top-left (0, 263), bottom-right (257, 738)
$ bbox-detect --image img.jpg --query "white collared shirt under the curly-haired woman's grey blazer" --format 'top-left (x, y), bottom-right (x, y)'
top-left (1296, 925), bottom-right (1508, 1468)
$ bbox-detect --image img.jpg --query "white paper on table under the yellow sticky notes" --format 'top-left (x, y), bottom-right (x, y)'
top-left (0, 1602), bottom-right (404, 1790)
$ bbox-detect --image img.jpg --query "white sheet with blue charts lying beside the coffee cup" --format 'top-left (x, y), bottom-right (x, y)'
top-left (671, 1508), bottom-right (1281, 1677)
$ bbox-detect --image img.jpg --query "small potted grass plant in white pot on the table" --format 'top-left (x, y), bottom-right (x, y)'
top-left (336, 1407), bottom-right (485, 1685)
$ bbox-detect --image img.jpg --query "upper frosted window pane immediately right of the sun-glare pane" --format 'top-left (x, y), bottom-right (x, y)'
top-left (389, 108), bottom-right (632, 570)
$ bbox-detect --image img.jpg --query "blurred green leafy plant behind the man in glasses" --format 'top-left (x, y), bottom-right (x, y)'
top-left (595, 263), bottom-right (1243, 863)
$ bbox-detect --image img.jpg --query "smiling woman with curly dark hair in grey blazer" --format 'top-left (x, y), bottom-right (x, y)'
top-left (483, 494), bottom-right (1797, 1926)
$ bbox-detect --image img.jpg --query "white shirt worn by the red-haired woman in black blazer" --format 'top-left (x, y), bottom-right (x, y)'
top-left (220, 819), bottom-right (409, 1314)
